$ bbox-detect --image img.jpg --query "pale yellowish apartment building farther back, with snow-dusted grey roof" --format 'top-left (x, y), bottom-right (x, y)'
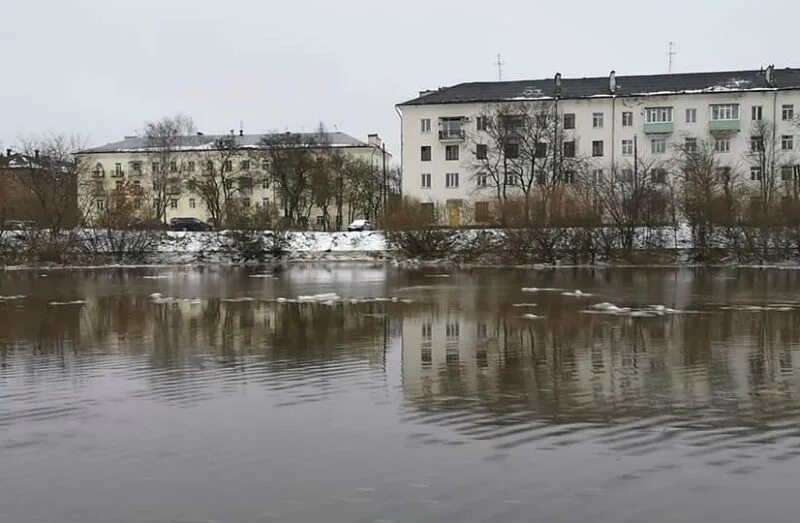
top-left (78, 132), bottom-right (391, 229)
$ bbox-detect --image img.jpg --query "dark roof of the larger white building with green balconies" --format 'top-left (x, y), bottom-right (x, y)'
top-left (399, 68), bottom-right (800, 106)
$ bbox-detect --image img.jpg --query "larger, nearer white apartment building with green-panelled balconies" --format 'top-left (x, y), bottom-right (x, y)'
top-left (397, 66), bottom-right (800, 226)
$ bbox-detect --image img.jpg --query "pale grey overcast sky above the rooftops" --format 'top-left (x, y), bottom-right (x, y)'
top-left (0, 0), bottom-right (800, 154)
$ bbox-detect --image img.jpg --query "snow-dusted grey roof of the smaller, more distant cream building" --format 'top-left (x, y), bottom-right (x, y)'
top-left (81, 132), bottom-right (368, 154)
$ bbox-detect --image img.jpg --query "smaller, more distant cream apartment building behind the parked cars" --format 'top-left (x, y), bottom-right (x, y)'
top-left (78, 131), bottom-right (391, 228)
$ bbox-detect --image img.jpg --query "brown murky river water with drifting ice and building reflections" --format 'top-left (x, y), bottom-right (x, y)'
top-left (0, 264), bottom-right (800, 523)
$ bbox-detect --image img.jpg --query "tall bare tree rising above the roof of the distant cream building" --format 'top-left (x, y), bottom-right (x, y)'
top-left (142, 114), bottom-right (195, 222)
